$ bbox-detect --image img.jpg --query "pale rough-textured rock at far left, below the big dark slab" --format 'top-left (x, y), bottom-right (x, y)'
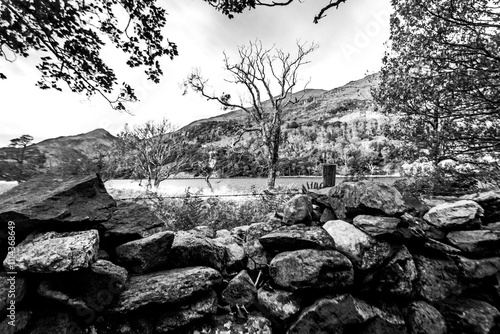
top-left (3, 230), bottom-right (99, 273)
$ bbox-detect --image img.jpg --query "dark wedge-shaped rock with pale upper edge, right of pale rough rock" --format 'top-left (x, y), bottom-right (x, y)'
top-left (116, 231), bottom-right (174, 274)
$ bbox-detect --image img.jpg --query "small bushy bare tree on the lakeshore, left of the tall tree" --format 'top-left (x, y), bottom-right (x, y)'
top-left (119, 119), bottom-right (187, 188)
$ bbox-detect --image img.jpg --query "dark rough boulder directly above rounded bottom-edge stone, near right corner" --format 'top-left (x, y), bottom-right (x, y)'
top-left (413, 255), bottom-right (463, 303)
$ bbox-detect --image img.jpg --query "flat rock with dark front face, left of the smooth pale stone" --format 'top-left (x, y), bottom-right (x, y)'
top-left (259, 225), bottom-right (335, 253)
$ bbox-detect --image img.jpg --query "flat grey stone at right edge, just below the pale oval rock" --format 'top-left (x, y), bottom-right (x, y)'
top-left (446, 230), bottom-right (500, 257)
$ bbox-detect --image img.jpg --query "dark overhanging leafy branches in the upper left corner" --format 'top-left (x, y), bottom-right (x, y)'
top-left (0, 0), bottom-right (177, 110)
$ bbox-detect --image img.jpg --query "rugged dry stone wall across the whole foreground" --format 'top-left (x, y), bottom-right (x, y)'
top-left (0, 177), bottom-right (500, 334)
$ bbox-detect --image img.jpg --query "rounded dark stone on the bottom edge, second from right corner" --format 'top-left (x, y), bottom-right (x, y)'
top-left (405, 301), bottom-right (447, 334)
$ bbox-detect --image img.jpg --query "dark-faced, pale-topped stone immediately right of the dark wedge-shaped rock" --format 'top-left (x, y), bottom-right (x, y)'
top-left (168, 231), bottom-right (226, 271)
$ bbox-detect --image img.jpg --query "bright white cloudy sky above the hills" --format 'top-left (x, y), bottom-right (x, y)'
top-left (0, 0), bottom-right (391, 147)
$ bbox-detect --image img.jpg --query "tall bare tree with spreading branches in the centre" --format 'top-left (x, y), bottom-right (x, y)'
top-left (184, 41), bottom-right (318, 188)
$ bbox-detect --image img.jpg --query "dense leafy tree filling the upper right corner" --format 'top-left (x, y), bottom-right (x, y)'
top-left (375, 0), bottom-right (500, 165)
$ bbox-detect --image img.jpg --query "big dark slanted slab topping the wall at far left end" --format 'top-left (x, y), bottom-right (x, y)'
top-left (0, 174), bottom-right (116, 240)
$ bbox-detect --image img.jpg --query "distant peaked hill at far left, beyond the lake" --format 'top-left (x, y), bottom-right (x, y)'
top-left (0, 129), bottom-right (118, 181)
